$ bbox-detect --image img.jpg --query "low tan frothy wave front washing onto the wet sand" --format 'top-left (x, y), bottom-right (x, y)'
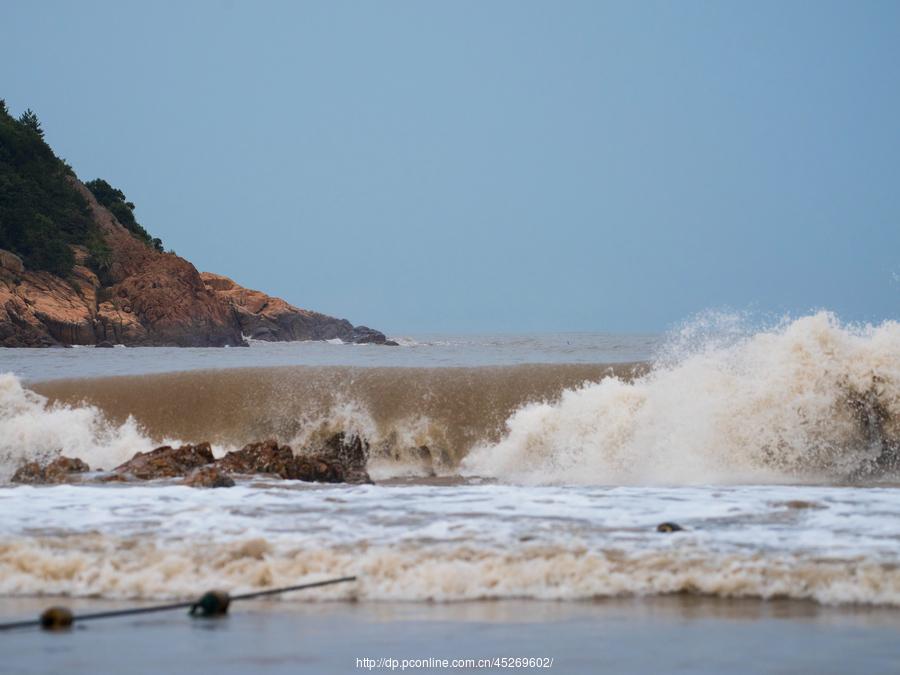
top-left (0, 535), bottom-right (900, 606)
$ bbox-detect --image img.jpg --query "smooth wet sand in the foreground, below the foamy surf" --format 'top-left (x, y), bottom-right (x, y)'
top-left (0, 596), bottom-right (900, 675)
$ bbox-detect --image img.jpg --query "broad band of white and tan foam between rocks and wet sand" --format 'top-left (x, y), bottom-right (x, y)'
top-left (0, 484), bottom-right (900, 605)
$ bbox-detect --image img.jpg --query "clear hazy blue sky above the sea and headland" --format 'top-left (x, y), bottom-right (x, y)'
top-left (0, 0), bottom-right (900, 333)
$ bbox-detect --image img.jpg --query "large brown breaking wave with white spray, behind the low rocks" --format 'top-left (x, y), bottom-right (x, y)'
top-left (0, 312), bottom-right (900, 484)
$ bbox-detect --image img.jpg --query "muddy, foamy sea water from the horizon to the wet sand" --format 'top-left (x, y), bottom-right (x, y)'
top-left (0, 312), bottom-right (900, 607)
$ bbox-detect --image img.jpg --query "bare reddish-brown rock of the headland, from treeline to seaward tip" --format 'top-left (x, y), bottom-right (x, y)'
top-left (0, 178), bottom-right (386, 347)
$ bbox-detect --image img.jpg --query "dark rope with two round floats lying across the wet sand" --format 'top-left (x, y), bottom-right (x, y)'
top-left (0, 577), bottom-right (356, 630)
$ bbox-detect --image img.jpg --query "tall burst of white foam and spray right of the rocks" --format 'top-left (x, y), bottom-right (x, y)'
top-left (463, 312), bottom-right (900, 484)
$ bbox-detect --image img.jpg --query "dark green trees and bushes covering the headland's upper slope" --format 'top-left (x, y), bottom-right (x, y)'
top-left (0, 99), bottom-right (162, 277)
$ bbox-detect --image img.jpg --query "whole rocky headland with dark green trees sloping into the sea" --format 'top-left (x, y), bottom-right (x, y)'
top-left (0, 106), bottom-right (391, 347)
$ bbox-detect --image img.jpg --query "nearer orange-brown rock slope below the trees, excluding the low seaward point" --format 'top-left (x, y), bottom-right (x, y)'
top-left (0, 178), bottom-right (244, 347)
